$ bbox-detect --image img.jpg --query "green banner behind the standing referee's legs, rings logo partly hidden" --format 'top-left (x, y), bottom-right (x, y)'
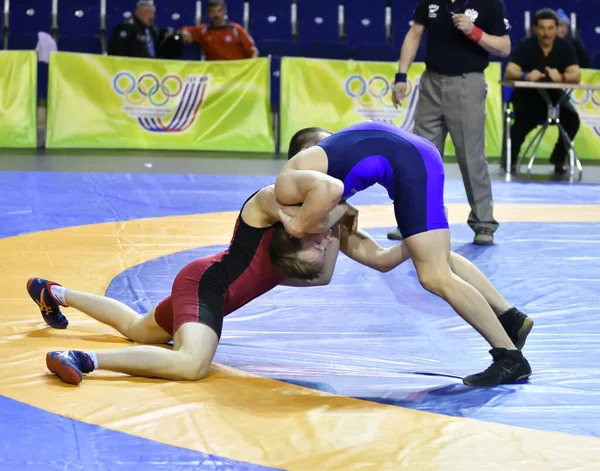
top-left (281, 57), bottom-right (502, 156)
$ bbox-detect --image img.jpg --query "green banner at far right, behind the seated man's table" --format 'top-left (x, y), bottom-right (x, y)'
top-left (521, 69), bottom-right (600, 159)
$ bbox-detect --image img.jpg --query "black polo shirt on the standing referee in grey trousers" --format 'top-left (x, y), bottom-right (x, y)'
top-left (413, 0), bottom-right (509, 75)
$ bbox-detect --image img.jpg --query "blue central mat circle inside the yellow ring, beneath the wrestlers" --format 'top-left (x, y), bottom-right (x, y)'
top-left (107, 223), bottom-right (600, 436)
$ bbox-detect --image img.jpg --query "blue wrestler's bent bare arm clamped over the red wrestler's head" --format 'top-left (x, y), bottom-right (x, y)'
top-left (275, 167), bottom-right (344, 237)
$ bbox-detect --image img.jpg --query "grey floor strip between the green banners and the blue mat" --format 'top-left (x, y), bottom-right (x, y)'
top-left (0, 149), bottom-right (600, 183)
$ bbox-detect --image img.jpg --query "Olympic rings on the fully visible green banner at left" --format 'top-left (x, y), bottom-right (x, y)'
top-left (113, 72), bottom-right (183, 106)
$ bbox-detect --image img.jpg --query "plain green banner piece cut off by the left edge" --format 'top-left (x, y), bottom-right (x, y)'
top-left (0, 51), bottom-right (37, 148)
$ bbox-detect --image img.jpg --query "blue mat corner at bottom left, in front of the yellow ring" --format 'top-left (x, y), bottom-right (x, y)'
top-left (0, 396), bottom-right (276, 471)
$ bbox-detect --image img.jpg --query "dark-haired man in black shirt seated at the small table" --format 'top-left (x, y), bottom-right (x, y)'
top-left (506, 8), bottom-right (581, 175)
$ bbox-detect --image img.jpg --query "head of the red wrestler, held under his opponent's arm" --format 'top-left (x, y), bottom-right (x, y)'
top-left (269, 224), bottom-right (332, 280)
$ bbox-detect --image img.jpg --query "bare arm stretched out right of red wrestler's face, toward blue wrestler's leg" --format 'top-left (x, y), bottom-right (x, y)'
top-left (340, 227), bottom-right (410, 272)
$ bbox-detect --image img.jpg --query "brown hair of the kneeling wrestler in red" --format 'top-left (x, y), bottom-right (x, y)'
top-left (269, 223), bottom-right (325, 280)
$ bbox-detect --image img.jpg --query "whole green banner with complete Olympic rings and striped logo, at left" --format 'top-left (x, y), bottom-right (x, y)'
top-left (46, 52), bottom-right (274, 152)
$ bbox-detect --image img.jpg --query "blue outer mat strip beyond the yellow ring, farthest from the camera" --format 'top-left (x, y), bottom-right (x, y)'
top-left (0, 172), bottom-right (600, 237)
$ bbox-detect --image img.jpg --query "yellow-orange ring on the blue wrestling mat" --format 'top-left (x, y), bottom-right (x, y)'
top-left (0, 204), bottom-right (600, 471)
